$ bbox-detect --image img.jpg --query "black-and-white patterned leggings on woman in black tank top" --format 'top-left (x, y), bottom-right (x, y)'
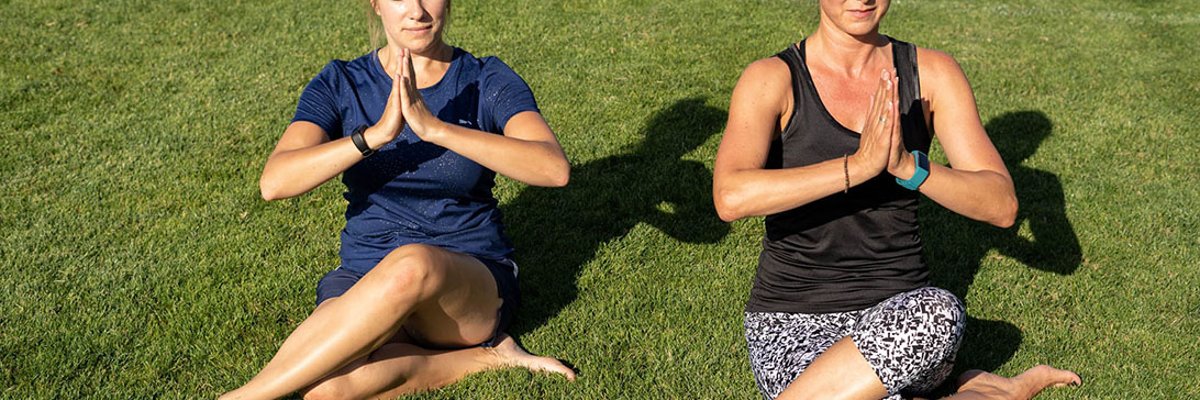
top-left (745, 287), bottom-right (966, 400)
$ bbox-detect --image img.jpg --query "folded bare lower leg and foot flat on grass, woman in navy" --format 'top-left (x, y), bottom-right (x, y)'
top-left (305, 335), bottom-right (575, 399)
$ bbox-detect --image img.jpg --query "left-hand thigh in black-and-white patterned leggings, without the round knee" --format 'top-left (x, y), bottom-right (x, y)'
top-left (745, 312), bottom-right (854, 399)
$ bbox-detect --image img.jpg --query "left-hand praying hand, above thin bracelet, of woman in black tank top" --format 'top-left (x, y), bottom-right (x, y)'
top-left (850, 70), bottom-right (900, 177)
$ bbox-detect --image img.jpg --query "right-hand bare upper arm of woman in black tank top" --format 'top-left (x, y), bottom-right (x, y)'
top-left (922, 52), bottom-right (1008, 177)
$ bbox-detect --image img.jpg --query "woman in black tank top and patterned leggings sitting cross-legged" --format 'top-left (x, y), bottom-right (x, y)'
top-left (713, 0), bottom-right (1080, 399)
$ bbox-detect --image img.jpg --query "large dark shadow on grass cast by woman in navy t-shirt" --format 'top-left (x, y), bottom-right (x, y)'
top-left (503, 97), bottom-right (730, 336)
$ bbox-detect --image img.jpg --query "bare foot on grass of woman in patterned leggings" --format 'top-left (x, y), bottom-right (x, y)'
top-left (959, 365), bottom-right (1084, 400)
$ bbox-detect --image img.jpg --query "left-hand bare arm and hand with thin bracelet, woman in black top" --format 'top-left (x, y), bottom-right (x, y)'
top-left (713, 58), bottom-right (899, 221)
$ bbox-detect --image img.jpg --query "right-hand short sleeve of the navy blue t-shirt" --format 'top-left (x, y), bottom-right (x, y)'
top-left (480, 58), bottom-right (540, 133)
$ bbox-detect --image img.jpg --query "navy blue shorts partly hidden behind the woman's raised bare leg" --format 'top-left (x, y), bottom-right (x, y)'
top-left (317, 257), bottom-right (521, 347)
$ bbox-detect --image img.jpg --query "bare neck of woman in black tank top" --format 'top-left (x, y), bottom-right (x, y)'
top-left (808, 14), bottom-right (888, 77)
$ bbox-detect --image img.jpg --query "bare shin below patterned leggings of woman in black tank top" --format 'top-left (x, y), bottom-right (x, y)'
top-left (775, 336), bottom-right (888, 400)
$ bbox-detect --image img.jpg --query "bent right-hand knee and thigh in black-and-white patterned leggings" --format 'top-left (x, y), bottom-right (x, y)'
top-left (851, 287), bottom-right (966, 394)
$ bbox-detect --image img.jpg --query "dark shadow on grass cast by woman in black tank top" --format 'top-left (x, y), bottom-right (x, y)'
top-left (920, 111), bottom-right (1082, 384)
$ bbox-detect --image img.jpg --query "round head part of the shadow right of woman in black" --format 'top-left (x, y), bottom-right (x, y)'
top-left (985, 111), bottom-right (1054, 167)
